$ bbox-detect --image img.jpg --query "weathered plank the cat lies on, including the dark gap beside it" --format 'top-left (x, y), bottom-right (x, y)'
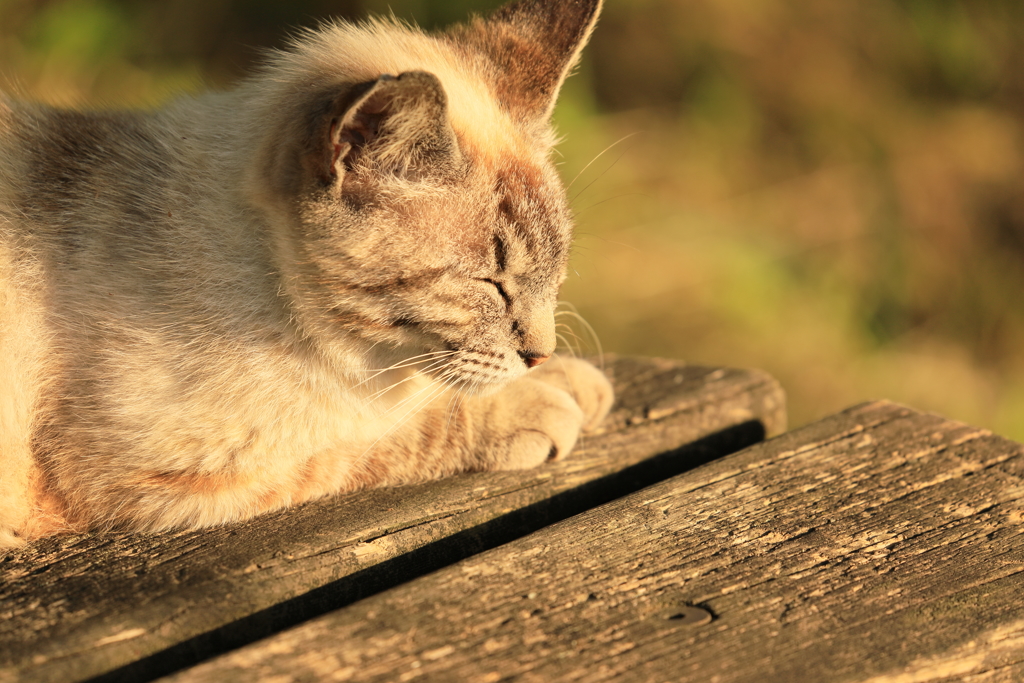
top-left (0, 358), bottom-right (785, 682)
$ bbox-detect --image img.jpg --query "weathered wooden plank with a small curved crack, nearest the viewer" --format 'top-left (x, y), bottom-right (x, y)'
top-left (169, 402), bottom-right (1024, 683)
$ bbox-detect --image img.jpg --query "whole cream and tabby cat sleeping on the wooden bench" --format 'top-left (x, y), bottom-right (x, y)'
top-left (0, 0), bottom-right (612, 546)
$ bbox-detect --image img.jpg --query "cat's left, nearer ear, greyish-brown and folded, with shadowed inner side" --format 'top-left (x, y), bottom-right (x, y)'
top-left (304, 72), bottom-right (458, 188)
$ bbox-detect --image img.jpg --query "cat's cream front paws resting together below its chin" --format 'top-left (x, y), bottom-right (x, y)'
top-left (477, 358), bottom-right (614, 470)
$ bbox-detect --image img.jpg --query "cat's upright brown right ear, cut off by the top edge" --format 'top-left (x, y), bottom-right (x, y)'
top-left (452, 0), bottom-right (601, 120)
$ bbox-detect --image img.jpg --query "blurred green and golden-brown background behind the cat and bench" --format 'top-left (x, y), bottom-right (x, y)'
top-left (0, 0), bottom-right (1024, 439)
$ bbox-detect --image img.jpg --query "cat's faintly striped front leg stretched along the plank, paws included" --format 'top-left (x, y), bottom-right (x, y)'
top-left (46, 358), bottom-right (612, 530)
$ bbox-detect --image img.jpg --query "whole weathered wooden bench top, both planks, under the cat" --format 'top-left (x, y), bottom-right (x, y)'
top-left (8, 359), bottom-right (1024, 683)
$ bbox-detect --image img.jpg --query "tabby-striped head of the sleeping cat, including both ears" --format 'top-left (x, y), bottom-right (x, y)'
top-left (256, 0), bottom-right (600, 389)
